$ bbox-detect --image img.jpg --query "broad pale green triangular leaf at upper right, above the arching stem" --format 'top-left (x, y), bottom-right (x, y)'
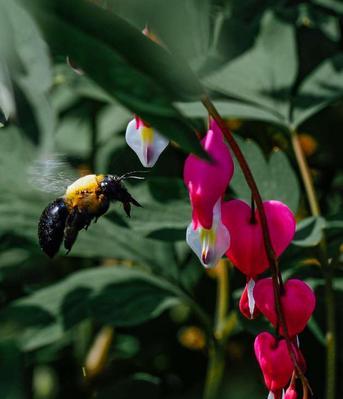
top-left (205, 11), bottom-right (297, 125)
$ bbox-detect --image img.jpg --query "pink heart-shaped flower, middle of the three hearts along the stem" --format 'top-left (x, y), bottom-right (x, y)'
top-left (254, 278), bottom-right (316, 338)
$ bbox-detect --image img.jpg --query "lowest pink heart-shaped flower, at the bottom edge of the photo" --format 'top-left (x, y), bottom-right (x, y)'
top-left (254, 332), bottom-right (294, 399)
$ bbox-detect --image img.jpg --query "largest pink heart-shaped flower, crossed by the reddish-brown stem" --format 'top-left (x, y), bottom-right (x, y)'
top-left (222, 200), bottom-right (296, 278)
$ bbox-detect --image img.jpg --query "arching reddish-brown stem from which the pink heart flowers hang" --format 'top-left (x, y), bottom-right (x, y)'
top-left (201, 95), bottom-right (308, 386)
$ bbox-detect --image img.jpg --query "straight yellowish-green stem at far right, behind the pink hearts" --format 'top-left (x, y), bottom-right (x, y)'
top-left (291, 130), bottom-right (336, 399)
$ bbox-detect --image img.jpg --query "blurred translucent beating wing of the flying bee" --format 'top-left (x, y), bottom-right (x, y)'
top-left (27, 154), bottom-right (77, 195)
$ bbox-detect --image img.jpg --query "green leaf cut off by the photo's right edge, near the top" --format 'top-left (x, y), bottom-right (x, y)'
top-left (291, 54), bottom-right (343, 128)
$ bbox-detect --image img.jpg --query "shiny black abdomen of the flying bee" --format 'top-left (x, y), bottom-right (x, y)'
top-left (38, 198), bottom-right (68, 258)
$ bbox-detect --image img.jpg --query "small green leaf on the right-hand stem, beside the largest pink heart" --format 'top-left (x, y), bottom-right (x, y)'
top-left (292, 216), bottom-right (326, 247)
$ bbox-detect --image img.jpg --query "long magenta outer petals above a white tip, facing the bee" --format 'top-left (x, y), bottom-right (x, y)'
top-left (184, 121), bottom-right (234, 229)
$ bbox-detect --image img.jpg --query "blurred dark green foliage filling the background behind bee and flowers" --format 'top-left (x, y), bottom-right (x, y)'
top-left (0, 0), bottom-right (343, 399)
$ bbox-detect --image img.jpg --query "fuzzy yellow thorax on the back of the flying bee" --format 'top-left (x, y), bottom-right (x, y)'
top-left (64, 175), bottom-right (104, 213)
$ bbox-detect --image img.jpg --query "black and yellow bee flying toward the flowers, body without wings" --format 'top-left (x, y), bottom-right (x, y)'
top-left (38, 172), bottom-right (142, 258)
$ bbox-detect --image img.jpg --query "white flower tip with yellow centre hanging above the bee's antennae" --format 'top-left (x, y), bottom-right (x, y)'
top-left (125, 117), bottom-right (169, 168)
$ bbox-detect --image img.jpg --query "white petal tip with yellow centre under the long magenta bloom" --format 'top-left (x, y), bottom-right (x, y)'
top-left (186, 200), bottom-right (230, 268)
